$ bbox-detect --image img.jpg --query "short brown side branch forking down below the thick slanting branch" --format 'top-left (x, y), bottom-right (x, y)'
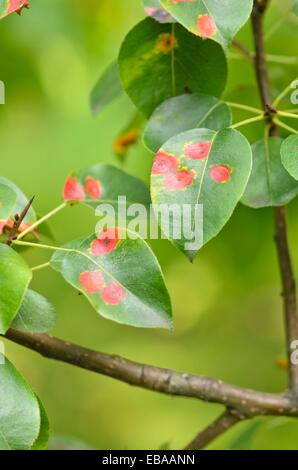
top-left (184, 409), bottom-right (245, 450)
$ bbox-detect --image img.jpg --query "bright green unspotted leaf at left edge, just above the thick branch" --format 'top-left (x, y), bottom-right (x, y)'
top-left (0, 244), bottom-right (32, 334)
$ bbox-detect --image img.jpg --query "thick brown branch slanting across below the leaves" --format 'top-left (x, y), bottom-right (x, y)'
top-left (5, 329), bottom-right (298, 417)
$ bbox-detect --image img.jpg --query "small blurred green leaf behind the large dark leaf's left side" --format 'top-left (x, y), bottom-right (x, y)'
top-left (90, 62), bottom-right (123, 114)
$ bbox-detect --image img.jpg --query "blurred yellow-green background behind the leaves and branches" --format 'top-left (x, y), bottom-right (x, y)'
top-left (0, 0), bottom-right (298, 449)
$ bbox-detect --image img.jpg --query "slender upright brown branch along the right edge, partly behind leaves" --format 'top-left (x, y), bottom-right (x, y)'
top-left (252, 0), bottom-right (298, 393)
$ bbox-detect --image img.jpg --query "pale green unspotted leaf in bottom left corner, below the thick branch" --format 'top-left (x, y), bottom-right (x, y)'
top-left (0, 358), bottom-right (40, 450)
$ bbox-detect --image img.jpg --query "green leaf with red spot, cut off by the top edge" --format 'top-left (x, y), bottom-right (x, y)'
top-left (161, 0), bottom-right (253, 47)
